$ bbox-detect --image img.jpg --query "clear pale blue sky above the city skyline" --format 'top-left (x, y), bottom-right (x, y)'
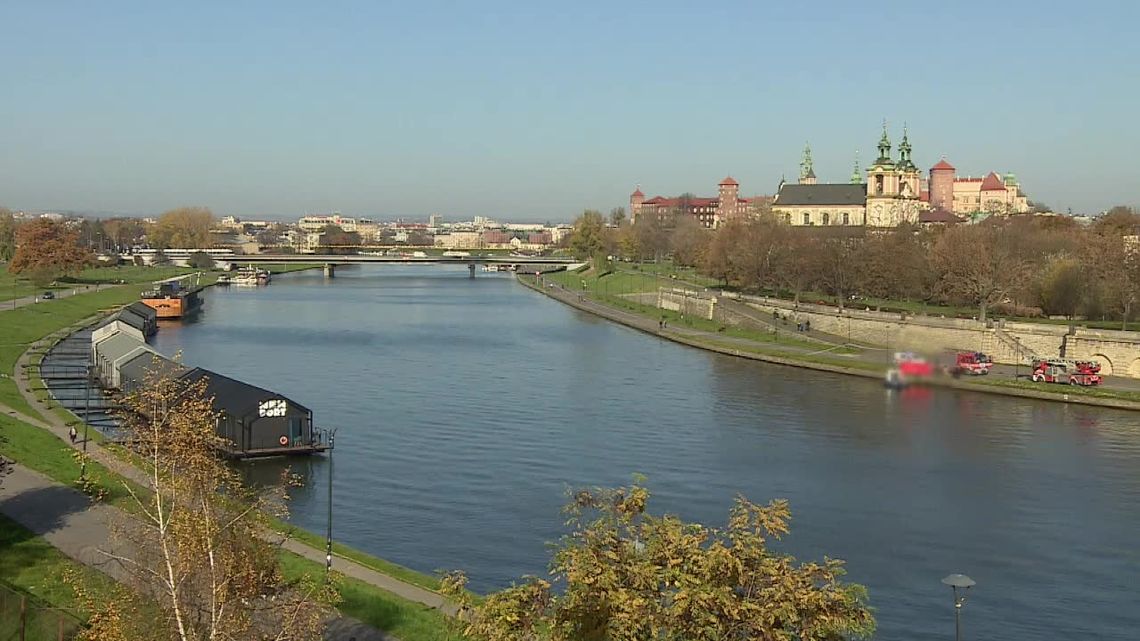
top-left (0, 0), bottom-right (1140, 220)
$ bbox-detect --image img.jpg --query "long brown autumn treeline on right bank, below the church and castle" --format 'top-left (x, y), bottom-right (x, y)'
top-left (571, 206), bottom-right (1140, 322)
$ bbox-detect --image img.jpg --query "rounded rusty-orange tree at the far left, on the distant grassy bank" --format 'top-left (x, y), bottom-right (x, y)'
top-left (8, 218), bottom-right (90, 285)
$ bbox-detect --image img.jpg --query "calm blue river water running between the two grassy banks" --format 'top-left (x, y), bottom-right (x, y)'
top-left (156, 266), bottom-right (1140, 641)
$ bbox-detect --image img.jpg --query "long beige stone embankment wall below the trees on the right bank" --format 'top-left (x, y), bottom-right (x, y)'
top-left (725, 294), bottom-right (1140, 378)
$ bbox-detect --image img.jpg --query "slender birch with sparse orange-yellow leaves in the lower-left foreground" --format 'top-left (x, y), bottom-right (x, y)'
top-left (86, 364), bottom-right (335, 641)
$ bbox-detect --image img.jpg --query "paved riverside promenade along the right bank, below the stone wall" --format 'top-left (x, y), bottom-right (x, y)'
top-left (516, 275), bottom-right (1140, 411)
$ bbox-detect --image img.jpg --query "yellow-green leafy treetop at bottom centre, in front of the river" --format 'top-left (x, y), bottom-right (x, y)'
top-left (443, 485), bottom-right (874, 641)
